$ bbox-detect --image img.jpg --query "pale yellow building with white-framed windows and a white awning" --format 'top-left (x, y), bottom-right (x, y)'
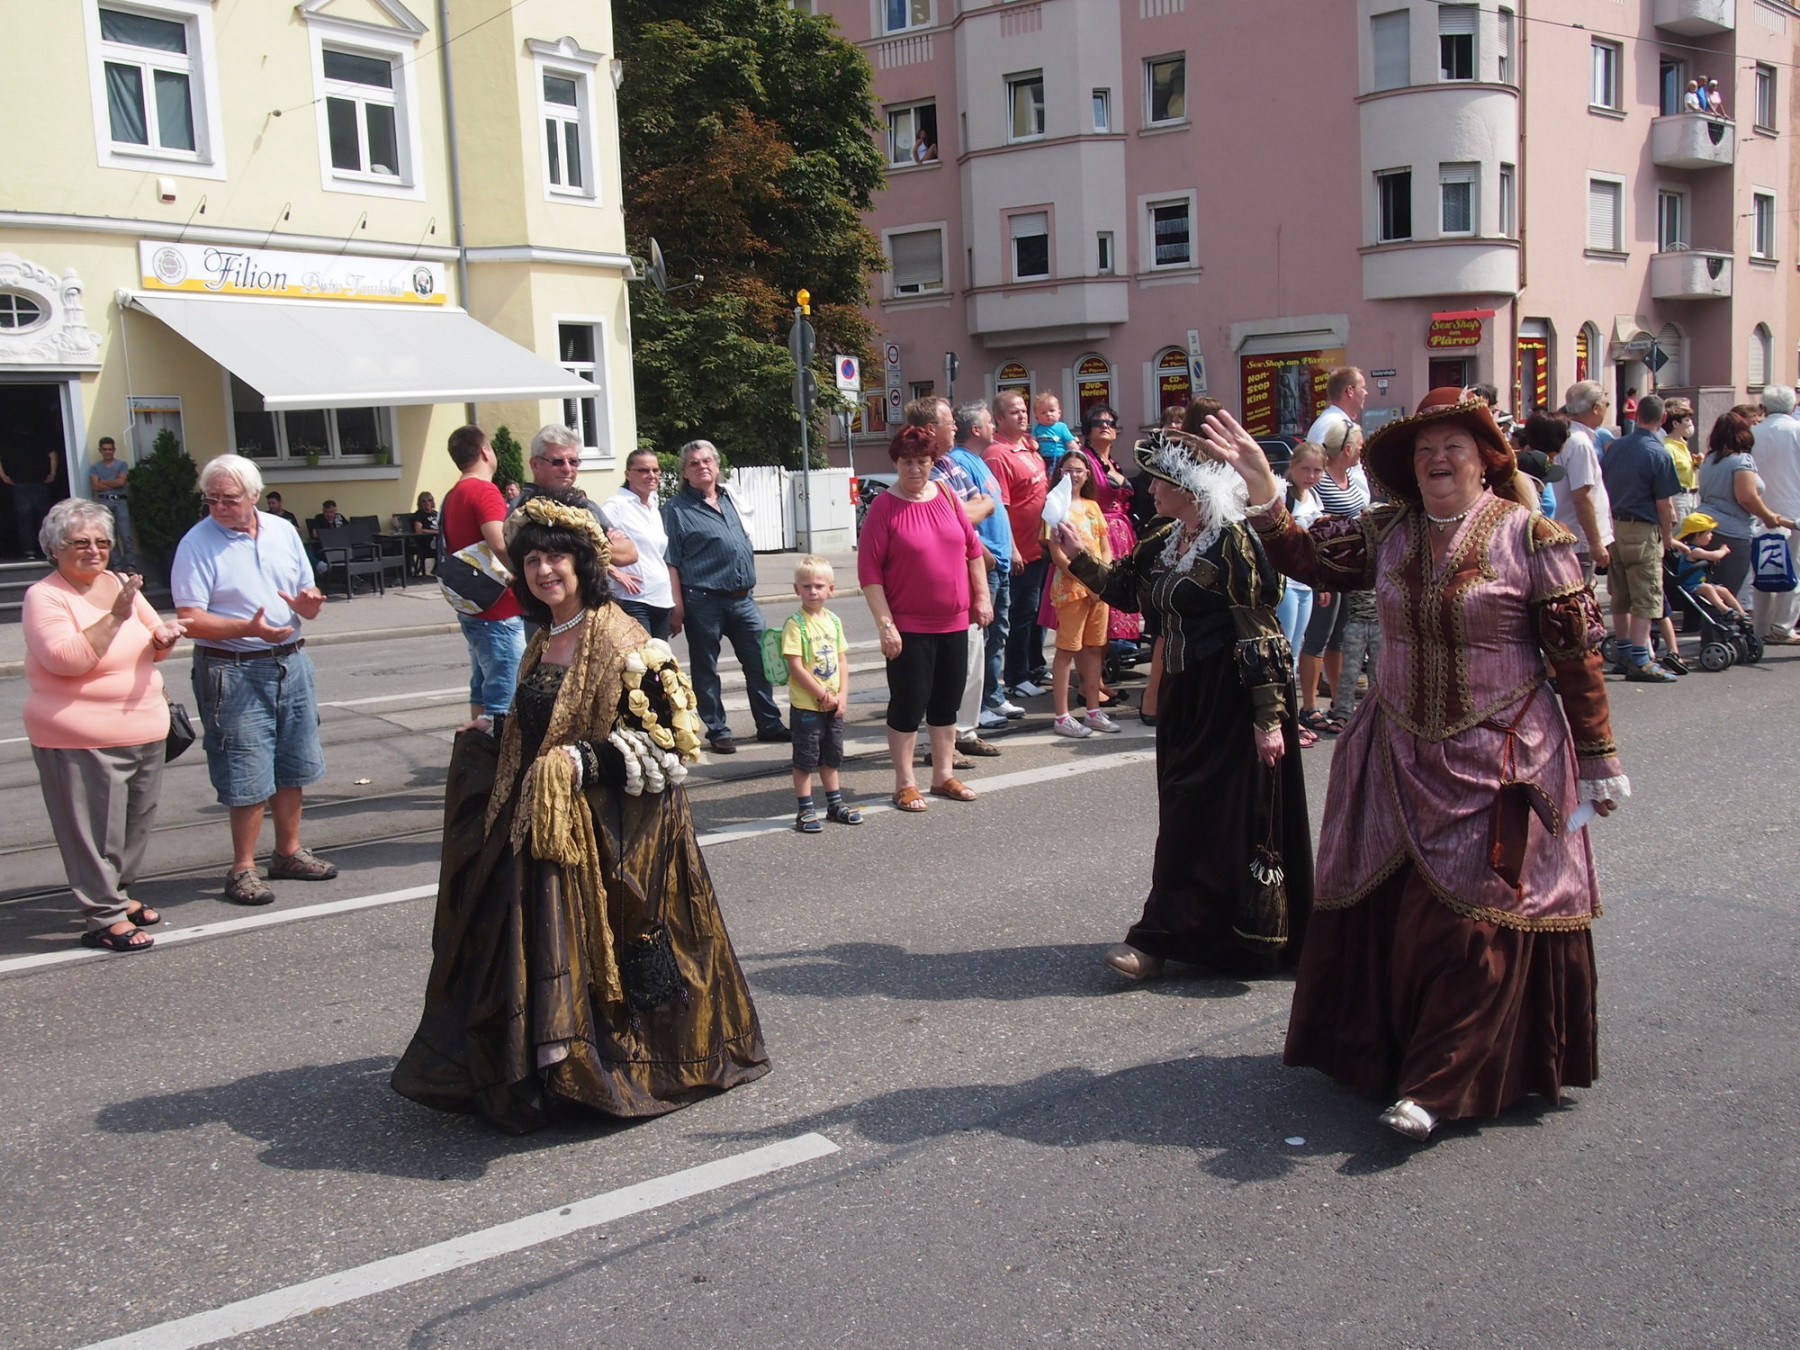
top-left (0, 0), bottom-right (637, 556)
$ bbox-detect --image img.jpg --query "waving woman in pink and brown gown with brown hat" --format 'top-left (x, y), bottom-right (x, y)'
top-left (1204, 389), bottom-right (1631, 1139)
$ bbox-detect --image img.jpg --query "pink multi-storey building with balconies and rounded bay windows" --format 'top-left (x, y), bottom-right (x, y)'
top-left (817, 0), bottom-right (1800, 457)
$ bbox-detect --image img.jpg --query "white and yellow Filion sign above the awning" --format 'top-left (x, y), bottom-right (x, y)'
top-left (137, 239), bottom-right (448, 304)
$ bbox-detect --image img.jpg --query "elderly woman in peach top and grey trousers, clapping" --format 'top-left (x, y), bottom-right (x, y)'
top-left (23, 499), bottom-right (182, 952)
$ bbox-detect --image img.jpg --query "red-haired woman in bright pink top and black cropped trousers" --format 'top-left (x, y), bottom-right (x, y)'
top-left (857, 427), bottom-right (994, 812)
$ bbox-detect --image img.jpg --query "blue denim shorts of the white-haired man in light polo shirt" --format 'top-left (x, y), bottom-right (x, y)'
top-left (193, 646), bottom-right (326, 806)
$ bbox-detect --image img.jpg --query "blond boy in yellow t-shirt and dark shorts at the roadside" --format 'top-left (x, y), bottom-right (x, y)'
top-left (781, 556), bottom-right (862, 835)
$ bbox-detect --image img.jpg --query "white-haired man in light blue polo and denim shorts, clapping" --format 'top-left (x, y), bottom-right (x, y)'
top-left (169, 455), bottom-right (337, 905)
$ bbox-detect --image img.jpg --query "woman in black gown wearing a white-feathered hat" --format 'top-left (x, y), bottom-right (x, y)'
top-left (1057, 432), bottom-right (1312, 979)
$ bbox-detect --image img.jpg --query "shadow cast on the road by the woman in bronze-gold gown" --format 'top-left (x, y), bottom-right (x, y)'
top-left (95, 1055), bottom-right (635, 1181)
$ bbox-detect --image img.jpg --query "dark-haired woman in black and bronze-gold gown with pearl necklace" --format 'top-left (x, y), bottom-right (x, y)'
top-left (392, 493), bottom-right (769, 1134)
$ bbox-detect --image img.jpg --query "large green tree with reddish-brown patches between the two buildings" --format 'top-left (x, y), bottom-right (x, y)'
top-left (614, 0), bottom-right (886, 466)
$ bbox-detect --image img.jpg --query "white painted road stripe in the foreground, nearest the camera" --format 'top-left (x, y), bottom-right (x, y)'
top-left (83, 1134), bottom-right (837, 1350)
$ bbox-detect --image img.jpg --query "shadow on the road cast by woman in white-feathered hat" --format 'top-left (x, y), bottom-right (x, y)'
top-left (740, 941), bottom-right (1249, 1003)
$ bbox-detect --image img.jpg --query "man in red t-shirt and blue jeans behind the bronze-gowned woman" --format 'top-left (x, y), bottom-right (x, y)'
top-left (439, 427), bottom-right (526, 731)
